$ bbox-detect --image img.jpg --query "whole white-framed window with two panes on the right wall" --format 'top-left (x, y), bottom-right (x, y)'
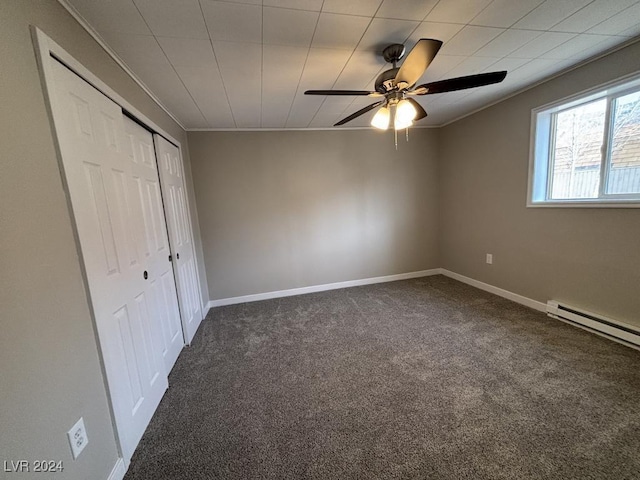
top-left (528, 74), bottom-right (640, 207)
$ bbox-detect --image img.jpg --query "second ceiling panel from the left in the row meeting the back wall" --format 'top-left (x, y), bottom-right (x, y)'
top-left (176, 66), bottom-right (235, 128)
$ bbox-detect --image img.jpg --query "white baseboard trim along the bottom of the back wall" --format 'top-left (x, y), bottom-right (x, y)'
top-left (207, 268), bottom-right (441, 310)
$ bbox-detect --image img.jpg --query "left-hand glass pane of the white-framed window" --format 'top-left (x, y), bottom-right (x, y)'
top-left (551, 99), bottom-right (607, 200)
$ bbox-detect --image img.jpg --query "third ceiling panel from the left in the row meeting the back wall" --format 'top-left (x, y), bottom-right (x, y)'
top-left (213, 42), bottom-right (262, 128)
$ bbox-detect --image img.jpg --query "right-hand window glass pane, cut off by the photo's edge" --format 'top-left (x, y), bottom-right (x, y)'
top-left (607, 92), bottom-right (640, 194)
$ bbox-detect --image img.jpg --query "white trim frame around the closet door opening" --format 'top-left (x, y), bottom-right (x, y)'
top-left (31, 26), bottom-right (204, 466)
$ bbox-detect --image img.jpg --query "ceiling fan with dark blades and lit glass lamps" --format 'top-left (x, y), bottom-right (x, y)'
top-left (304, 38), bottom-right (507, 130)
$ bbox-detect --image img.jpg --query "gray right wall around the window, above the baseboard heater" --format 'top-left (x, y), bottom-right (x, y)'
top-left (440, 43), bottom-right (640, 326)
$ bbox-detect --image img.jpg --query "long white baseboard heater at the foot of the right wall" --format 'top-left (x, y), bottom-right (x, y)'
top-left (547, 300), bottom-right (640, 348)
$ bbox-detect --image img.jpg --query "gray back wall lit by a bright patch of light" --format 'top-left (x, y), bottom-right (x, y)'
top-left (188, 129), bottom-right (439, 299)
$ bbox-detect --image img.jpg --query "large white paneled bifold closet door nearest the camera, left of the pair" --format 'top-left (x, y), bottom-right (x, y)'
top-left (49, 58), bottom-right (184, 463)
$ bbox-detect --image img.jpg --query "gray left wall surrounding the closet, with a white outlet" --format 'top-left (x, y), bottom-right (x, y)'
top-left (0, 0), bottom-right (206, 479)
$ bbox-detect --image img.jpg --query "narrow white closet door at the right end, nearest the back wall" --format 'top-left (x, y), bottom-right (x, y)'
top-left (154, 135), bottom-right (203, 343)
